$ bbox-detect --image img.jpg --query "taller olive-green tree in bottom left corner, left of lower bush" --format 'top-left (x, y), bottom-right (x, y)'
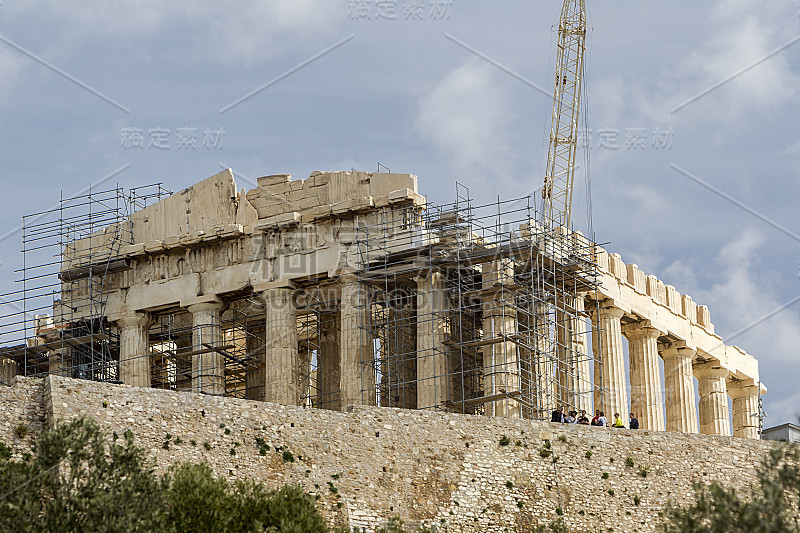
top-left (0, 418), bottom-right (164, 533)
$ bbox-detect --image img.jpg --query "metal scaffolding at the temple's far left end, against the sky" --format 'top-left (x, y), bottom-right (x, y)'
top-left (0, 184), bottom-right (169, 383)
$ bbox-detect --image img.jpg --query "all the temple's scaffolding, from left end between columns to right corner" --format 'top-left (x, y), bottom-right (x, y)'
top-left (0, 184), bottom-right (603, 419)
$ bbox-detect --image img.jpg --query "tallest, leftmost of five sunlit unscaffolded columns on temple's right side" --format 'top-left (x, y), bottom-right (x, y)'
top-left (592, 306), bottom-right (628, 420)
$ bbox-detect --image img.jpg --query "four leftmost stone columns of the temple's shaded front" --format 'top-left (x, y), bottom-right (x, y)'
top-left (115, 274), bottom-right (374, 409)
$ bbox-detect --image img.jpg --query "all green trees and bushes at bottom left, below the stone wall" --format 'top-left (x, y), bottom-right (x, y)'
top-left (0, 418), bottom-right (334, 533)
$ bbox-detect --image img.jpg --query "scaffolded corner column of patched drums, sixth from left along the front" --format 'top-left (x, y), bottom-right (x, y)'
top-left (482, 259), bottom-right (520, 418)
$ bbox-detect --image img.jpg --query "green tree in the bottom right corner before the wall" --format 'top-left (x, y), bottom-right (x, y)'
top-left (663, 446), bottom-right (800, 533)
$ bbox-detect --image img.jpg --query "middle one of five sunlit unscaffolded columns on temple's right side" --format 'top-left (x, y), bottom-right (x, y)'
top-left (661, 346), bottom-right (697, 433)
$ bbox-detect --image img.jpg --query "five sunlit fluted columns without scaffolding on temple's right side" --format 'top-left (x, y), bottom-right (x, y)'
top-left (592, 306), bottom-right (760, 439)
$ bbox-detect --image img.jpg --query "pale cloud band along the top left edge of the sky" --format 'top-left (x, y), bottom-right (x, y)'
top-left (4, 0), bottom-right (336, 63)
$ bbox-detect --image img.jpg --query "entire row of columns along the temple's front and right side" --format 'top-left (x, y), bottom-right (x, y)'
top-left (109, 268), bottom-right (759, 438)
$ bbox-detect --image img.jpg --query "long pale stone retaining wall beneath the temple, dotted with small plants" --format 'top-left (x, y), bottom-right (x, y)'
top-left (0, 376), bottom-right (770, 532)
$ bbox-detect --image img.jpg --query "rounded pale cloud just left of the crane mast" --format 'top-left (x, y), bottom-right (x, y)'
top-left (415, 59), bottom-right (511, 176)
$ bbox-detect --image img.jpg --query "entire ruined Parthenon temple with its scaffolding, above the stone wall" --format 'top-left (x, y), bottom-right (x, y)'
top-left (0, 169), bottom-right (766, 438)
